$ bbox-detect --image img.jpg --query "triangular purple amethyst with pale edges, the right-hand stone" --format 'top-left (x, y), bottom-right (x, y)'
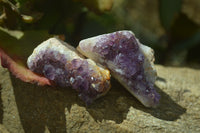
top-left (77, 31), bottom-right (160, 107)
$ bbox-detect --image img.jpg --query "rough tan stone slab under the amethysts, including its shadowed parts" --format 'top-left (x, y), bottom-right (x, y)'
top-left (0, 65), bottom-right (200, 133)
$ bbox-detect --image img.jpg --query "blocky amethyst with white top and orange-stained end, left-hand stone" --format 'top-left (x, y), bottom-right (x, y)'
top-left (27, 38), bottom-right (110, 104)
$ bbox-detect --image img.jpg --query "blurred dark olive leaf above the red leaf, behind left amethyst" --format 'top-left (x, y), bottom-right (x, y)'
top-left (0, 30), bottom-right (50, 60)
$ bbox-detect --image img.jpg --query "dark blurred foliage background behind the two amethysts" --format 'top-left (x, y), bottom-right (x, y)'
top-left (0, 0), bottom-right (200, 68)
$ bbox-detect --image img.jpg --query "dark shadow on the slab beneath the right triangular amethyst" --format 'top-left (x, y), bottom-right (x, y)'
top-left (88, 78), bottom-right (186, 123)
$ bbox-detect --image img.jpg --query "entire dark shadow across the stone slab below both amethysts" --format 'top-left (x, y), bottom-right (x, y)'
top-left (12, 74), bottom-right (186, 133)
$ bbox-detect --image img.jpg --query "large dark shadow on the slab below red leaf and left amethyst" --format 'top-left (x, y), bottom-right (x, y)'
top-left (11, 76), bottom-right (83, 133)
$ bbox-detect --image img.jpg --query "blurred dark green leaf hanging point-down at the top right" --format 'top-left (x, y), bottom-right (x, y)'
top-left (159, 0), bottom-right (182, 31)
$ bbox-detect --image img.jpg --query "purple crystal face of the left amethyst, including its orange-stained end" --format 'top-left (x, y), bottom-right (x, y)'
top-left (28, 38), bottom-right (110, 104)
